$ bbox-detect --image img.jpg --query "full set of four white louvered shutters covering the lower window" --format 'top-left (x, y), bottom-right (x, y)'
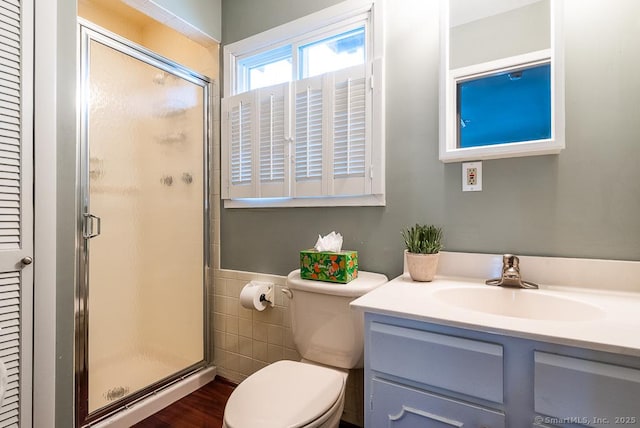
top-left (222, 65), bottom-right (380, 203)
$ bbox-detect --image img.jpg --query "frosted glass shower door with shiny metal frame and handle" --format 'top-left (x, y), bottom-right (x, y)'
top-left (76, 24), bottom-right (211, 426)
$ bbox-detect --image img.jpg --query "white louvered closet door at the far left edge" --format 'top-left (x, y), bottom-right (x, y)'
top-left (0, 0), bottom-right (33, 427)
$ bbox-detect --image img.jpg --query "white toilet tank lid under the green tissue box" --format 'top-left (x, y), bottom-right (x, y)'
top-left (287, 269), bottom-right (389, 297)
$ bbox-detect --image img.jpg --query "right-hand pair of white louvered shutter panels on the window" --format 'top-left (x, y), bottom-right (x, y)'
top-left (294, 66), bottom-right (371, 196)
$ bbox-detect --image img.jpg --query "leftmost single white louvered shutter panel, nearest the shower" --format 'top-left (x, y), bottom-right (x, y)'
top-left (222, 92), bottom-right (257, 198)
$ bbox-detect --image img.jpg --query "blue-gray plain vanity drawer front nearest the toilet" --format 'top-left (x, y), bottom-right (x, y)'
top-left (369, 322), bottom-right (503, 403)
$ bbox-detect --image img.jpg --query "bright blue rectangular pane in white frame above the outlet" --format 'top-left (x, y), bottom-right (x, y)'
top-left (457, 64), bottom-right (551, 148)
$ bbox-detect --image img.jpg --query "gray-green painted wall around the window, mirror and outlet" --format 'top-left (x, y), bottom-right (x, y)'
top-left (221, 0), bottom-right (640, 276)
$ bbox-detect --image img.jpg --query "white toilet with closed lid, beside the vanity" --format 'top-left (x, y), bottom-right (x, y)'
top-left (223, 269), bottom-right (388, 428)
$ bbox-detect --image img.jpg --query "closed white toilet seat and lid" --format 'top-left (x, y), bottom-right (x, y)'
top-left (224, 360), bottom-right (347, 428)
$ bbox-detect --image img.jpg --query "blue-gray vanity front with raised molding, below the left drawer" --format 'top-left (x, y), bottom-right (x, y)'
top-left (366, 378), bottom-right (505, 428)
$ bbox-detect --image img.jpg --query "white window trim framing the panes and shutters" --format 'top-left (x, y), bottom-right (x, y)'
top-left (221, 0), bottom-right (386, 208)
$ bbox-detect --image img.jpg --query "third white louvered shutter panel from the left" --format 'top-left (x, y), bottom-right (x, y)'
top-left (293, 76), bottom-right (327, 196)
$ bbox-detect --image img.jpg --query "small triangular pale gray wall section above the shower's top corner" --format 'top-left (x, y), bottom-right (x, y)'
top-left (153, 0), bottom-right (222, 41)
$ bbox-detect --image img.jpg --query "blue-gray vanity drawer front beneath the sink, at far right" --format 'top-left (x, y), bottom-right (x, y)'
top-left (534, 352), bottom-right (640, 427)
